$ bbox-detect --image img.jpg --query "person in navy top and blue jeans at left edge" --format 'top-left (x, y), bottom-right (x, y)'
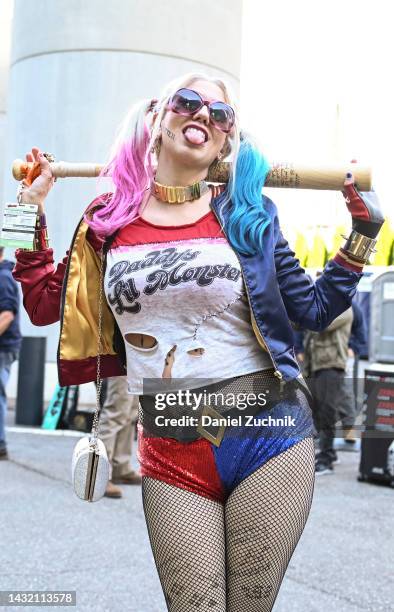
top-left (0, 247), bottom-right (22, 459)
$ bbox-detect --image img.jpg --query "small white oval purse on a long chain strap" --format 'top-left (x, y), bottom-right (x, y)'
top-left (71, 248), bottom-right (110, 502)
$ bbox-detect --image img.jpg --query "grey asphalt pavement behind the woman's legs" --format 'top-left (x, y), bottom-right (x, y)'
top-left (0, 414), bottom-right (394, 612)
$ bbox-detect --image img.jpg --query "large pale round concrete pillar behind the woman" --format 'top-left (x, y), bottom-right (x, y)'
top-left (4, 0), bottom-right (242, 361)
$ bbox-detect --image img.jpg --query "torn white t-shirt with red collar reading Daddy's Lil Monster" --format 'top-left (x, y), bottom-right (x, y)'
top-left (104, 213), bottom-right (272, 395)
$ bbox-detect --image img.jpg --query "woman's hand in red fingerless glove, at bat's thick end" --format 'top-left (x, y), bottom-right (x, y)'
top-left (342, 160), bottom-right (384, 238)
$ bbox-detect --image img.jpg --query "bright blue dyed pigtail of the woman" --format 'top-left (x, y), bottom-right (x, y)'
top-left (219, 136), bottom-right (271, 255)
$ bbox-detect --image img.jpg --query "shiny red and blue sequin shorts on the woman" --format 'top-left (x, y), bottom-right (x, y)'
top-left (137, 368), bottom-right (314, 502)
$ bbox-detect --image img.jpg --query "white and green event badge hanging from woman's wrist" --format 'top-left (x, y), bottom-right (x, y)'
top-left (0, 202), bottom-right (38, 251)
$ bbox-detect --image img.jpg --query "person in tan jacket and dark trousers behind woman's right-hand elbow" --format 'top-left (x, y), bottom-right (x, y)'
top-left (300, 308), bottom-right (353, 475)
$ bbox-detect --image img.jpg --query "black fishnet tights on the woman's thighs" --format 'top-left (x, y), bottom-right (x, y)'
top-left (142, 438), bottom-right (314, 612)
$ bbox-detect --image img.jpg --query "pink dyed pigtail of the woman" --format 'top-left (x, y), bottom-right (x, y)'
top-left (85, 100), bottom-right (153, 237)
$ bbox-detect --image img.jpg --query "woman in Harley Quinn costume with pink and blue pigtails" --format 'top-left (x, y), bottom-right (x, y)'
top-left (14, 74), bottom-right (383, 612)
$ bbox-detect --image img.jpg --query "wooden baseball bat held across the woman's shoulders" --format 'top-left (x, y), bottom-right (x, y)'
top-left (12, 159), bottom-right (372, 191)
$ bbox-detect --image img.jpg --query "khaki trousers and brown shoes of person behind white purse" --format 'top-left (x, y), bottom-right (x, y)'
top-left (100, 376), bottom-right (141, 498)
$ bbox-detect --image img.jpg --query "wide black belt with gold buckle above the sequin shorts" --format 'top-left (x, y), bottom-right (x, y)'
top-left (139, 369), bottom-right (309, 446)
